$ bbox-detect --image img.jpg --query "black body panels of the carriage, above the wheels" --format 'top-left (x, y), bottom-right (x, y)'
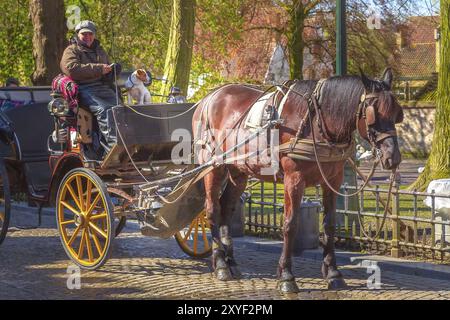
top-left (0, 87), bottom-right (194, 203)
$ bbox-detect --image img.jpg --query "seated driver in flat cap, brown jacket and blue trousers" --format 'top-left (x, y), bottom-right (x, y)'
top-left (60, 20), bottom-right (121, 152)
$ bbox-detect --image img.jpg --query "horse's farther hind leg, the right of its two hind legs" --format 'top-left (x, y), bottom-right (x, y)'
top-left (220, 168), bottom-right (247, 279)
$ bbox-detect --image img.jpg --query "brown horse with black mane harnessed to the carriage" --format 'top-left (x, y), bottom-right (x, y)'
top-left (193, 69), bottom-right (403, 292)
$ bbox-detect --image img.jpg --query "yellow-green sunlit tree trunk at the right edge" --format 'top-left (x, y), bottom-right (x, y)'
top-left (410, 0), bottom-right (450, 190)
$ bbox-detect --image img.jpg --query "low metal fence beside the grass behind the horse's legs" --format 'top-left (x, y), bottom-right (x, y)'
top-left (245, 181), bottom-right (450, 260)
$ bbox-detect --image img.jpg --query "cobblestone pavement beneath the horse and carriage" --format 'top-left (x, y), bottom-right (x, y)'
top-left (0, 210), bottom-right (450, 300)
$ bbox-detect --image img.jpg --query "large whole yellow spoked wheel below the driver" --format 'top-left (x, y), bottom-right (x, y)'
top-left (56, 168), bottom-right (115, 270)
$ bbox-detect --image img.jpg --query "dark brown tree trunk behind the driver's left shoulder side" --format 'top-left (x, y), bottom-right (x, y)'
top-left (30, 0), bottom-right (67, 85)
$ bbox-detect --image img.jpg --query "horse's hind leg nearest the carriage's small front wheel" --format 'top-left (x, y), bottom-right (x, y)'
top-left (205, 167), bottom-right (233, 281)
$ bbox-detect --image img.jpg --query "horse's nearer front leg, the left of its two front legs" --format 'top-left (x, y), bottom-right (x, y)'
top-left (278, 171), bottom-right (305, 293)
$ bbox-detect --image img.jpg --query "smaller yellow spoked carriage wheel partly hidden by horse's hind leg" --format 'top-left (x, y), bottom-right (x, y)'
top-left (175, 210), bottom-right (212, 259)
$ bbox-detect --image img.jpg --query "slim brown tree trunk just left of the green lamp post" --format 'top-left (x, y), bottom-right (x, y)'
top-left (287, 0), bottom-right (306, 80)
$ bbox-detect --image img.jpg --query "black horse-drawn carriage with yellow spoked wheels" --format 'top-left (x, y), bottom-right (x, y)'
top-left (0, 87), bottom-right (211, 269)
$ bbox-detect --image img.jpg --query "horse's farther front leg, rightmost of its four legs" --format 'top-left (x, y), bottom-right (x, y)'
top-left (322, 177), bottom-right (346, 289)
